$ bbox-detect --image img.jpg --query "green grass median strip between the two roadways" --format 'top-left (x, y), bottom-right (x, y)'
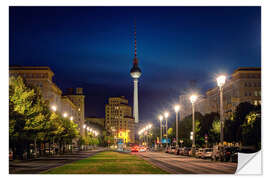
top-left (45, 151), bottom-right (168, 174)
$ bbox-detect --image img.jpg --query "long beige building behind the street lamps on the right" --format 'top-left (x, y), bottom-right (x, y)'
top-left (179, 67), bottom-right (261, 119)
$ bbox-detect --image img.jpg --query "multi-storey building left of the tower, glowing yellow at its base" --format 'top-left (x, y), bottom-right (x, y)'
top-left (105, 96), bottom-right (135, 143)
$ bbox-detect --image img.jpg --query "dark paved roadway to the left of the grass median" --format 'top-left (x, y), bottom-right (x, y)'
top-left (9, 148), bottom-right (106, 174)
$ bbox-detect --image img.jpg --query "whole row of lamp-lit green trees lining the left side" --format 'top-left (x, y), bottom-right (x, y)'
top-left (9, 76), bottom-right (78, 159)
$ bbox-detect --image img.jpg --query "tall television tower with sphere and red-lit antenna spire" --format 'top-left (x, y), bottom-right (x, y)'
top-left (130, 24), bottom-right (142, 123)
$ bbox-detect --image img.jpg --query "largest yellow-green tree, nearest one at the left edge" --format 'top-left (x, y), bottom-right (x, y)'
top-left (9, 76), bottom-right (49, 159)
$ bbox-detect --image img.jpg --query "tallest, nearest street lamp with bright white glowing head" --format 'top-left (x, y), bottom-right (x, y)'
top-left (217, 75), bottom-right (226, 150)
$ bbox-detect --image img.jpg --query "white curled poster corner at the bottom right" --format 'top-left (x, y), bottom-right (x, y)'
top-left (235, 151), bottom-right (262, 175)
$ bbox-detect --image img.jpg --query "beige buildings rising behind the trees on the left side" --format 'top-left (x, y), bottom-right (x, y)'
top-left (9, 66), bottom-right (84, 136)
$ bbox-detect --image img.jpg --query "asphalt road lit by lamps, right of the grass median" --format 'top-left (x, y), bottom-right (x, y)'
top-left (132, 152), bottom-right (237, 174)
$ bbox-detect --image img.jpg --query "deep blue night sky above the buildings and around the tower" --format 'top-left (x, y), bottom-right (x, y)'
top-left (9, 7), bottom-right (261, 126)
